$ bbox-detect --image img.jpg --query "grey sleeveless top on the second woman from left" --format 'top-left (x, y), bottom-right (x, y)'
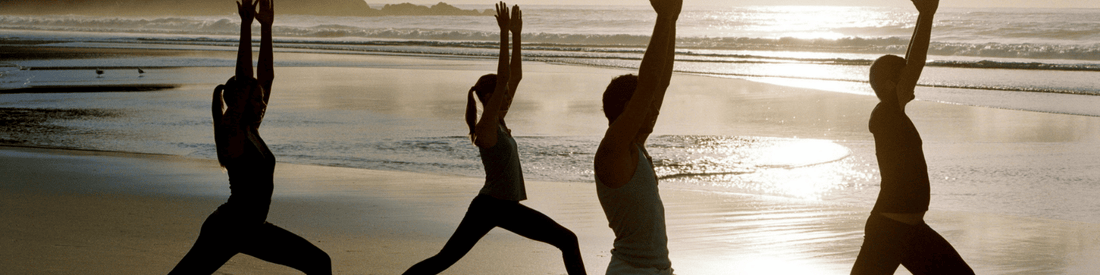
top-left (477, 127), bottom-right (527, 201)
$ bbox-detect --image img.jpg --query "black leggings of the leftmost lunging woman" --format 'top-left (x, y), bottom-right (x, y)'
top-left (168, 209), bottom-right (332, 274)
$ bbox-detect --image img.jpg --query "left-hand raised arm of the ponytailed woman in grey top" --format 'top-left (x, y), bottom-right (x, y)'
top-left (474, 2), bottom-right (509, 147)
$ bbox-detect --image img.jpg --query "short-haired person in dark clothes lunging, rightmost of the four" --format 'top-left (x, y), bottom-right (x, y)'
top-left (851, 0), bottom-right (974, 275)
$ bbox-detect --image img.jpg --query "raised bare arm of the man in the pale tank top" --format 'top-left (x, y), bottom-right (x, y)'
top-left (595, 0), bottom-right (683, 188)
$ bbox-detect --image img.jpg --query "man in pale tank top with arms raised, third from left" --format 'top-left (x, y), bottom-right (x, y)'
top-left (595, 0), bottom-right (682, 274)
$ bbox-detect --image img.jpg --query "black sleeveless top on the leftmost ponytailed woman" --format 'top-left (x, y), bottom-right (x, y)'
top-left (219, 132), bottom-right (275, 222)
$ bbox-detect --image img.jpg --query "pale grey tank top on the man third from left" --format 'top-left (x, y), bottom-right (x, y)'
top-left (596, 146), bottom-right (672, 270)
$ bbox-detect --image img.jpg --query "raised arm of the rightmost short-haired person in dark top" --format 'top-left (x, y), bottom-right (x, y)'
top-left (897, 0), bottom-right (939, 108)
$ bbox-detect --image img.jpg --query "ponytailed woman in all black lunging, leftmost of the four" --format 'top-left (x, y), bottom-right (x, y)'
top-left (171, 0), bottom-right (332, 274)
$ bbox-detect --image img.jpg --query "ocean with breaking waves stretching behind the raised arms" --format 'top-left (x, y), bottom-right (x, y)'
top-left (0, 6), bottom-right (1100, 95)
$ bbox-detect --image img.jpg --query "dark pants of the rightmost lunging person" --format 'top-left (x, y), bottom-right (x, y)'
top-left (851, 213), bottom-right (974, 275)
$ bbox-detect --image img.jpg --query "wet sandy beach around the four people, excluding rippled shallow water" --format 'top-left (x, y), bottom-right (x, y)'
top-left (0, 44), bottom-right (1100, 274)
